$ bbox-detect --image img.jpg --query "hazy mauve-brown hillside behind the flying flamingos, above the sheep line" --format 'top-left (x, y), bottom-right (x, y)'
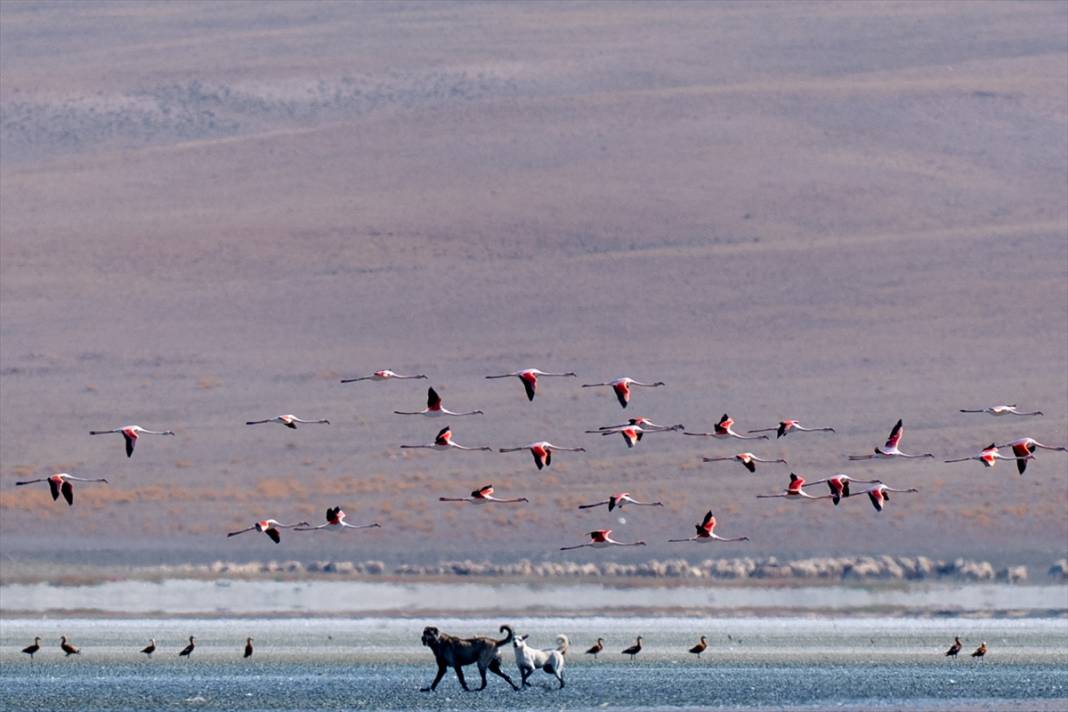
top-left (0, 2), bottom-right (1068, 563)
